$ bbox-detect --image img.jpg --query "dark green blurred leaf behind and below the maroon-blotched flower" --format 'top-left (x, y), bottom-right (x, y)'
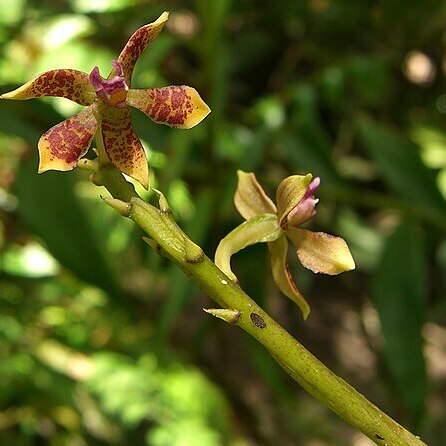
top-left (0, 101), bottom-right (119, 296)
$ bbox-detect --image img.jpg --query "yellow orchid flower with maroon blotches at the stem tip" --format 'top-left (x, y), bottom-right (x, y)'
top-left (0, 12), bottom-right (210, 188)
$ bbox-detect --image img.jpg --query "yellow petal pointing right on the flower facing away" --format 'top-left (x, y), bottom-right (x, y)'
top-left (287, 227), bottom-right (355, 275)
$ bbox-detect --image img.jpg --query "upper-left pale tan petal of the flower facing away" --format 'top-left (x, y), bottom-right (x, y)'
top-left (234, 170), bottom-right (276, 220)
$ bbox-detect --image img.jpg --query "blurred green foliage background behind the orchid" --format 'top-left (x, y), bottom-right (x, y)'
top-left (0, 0), bottom-right (446, 446)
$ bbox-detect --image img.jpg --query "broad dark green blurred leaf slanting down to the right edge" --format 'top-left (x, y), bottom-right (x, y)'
top-left (358, 118), bottom-right (445, 211)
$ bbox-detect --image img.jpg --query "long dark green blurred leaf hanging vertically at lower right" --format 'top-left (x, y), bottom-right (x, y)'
top-left (371, 224), bottom-right (427, 422)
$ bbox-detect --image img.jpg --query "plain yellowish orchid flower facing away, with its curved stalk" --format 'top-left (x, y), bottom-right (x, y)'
top-left (215, 170), bottom-right (355, 319)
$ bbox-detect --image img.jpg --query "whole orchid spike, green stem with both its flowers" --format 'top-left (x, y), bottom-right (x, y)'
top-left (1, 9), bottom-right (424, 445)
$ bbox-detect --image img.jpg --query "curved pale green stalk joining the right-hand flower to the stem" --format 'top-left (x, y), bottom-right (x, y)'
top-left (215, 214), bottom-right (283, 281)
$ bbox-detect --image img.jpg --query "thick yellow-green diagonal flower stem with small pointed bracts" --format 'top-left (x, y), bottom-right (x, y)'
top-left (98, 169), bottom-right (425, 446)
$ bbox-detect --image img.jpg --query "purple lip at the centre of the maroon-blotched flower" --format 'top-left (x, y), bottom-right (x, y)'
top-left (89, 60), bottom-right (129, 108)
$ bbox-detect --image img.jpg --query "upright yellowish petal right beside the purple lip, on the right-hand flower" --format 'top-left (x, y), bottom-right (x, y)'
top-left (276, 173), bottom-right (313, 229)
